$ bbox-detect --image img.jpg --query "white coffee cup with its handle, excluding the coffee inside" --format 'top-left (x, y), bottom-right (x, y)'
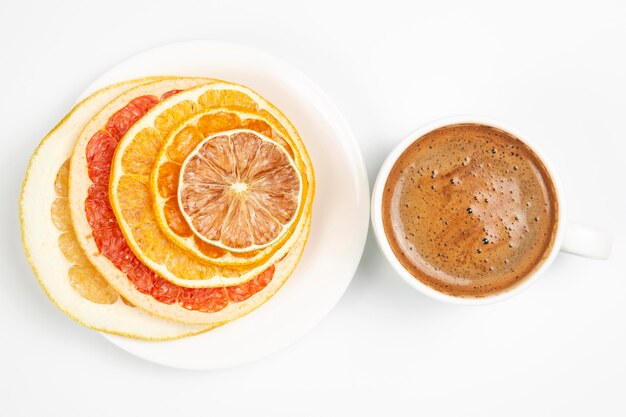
top-left (372, 116), bottom-right (612, 305)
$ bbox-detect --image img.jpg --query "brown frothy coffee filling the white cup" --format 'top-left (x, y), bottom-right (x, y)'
top-left (382, 124), bottom-right (558, 297)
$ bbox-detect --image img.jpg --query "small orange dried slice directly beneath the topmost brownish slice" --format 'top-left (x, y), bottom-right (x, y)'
top-left (150, 108), bottom-right (294, 266)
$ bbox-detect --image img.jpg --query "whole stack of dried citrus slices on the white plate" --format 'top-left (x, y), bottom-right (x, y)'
top-left (20, 77), bottom-right (315, 340)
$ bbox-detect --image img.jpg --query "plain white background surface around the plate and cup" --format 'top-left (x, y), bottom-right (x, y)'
top-left (0, 0), bottom-right (626, 417)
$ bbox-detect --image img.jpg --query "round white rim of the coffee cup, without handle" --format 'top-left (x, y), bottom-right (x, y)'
top-left (371, 115), bottom-right (566, 305)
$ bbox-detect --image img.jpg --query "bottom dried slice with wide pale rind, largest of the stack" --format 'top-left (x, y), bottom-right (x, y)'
top-left (20, 77), bottom-right (213, 340)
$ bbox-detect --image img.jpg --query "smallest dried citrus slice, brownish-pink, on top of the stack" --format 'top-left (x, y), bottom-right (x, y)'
top-left (178, 129), bottom-right (302, 252)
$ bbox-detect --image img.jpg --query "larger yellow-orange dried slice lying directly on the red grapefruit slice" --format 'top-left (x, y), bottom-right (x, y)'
top-left (109, 82), bottom-right (314, 288)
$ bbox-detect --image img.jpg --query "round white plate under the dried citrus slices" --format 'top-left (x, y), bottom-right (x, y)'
top-left (82, 41), bottom-right (369, 369)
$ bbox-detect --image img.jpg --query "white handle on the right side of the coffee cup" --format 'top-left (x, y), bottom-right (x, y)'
top-left (561, 222), bottom-right (613, 259)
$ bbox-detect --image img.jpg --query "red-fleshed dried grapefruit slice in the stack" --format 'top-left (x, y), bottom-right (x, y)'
top-left (69, 80), bottom-right (306, 328)
